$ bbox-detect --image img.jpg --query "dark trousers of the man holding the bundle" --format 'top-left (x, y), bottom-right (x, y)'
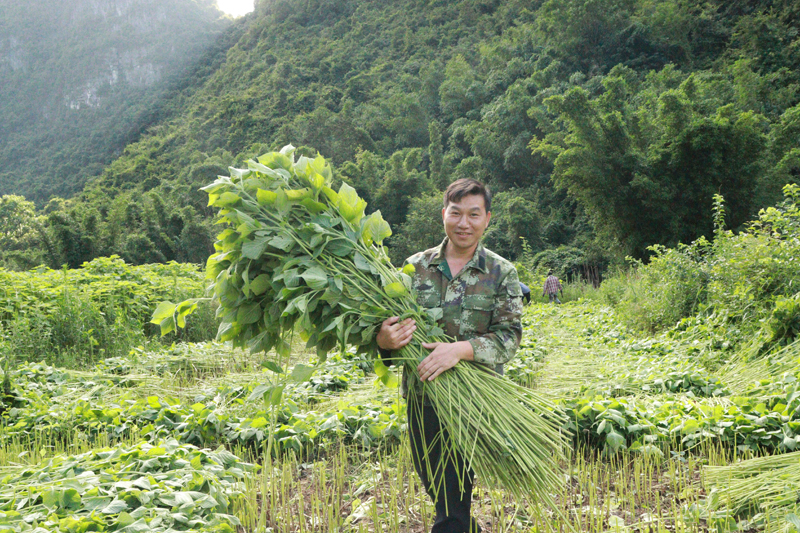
top-left (407, 395), bottom-right (481, 533)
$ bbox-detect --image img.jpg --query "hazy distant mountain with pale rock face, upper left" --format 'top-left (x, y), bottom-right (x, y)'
top-left (0, 0), bottom-right (231, 202)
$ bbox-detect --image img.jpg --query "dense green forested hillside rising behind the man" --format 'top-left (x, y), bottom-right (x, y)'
top-left (0, 0), bottom-right (800, 275)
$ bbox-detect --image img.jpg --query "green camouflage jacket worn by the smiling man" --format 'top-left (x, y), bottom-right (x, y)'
top-left (390, 238), bottom-right (522, 395)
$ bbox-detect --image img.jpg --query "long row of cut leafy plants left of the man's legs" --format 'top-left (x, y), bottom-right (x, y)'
top-left (0, 355), bottom-right (405, 456)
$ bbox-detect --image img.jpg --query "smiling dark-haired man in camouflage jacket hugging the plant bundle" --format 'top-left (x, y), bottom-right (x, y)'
top-left (377, 179), bottom-right (522, 533)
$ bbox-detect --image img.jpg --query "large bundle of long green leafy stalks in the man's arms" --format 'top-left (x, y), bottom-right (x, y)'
top-left (155, 146), bottom-right (565, 505)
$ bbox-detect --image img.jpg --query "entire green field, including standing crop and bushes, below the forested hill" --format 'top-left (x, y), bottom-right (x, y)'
top-left (0, 186), bottom-right (800, 533)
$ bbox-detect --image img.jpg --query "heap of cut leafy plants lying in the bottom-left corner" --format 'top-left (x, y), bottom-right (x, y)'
top-left (0, 439), bottom-right (256, 533)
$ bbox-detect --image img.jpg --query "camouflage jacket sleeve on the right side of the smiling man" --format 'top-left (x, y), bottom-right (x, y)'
top-left (469, 268), bottom-right (522, 366)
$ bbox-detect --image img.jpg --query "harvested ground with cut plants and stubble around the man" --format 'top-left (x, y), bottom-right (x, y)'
top-left (0, 278), bottom-right (800, 532)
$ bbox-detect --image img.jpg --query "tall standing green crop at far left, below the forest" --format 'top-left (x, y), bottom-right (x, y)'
top-left (0, 257), bottom-right (213, 367)
